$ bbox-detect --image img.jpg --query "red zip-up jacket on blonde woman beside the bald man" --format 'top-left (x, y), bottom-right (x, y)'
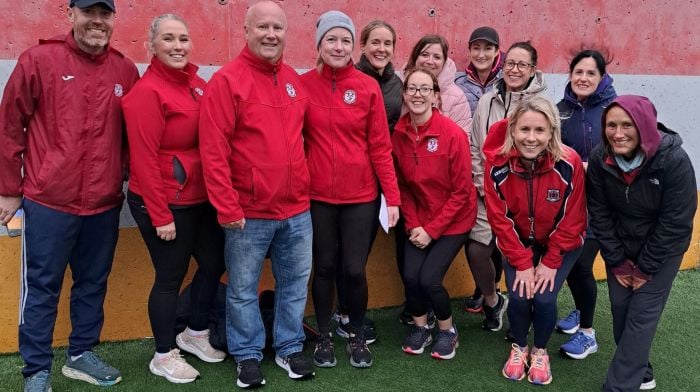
top-left (122, 56), bottom-right (207, 227)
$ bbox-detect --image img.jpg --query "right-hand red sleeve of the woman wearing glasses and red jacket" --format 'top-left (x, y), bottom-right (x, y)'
top-left (423, 129), bottom-right (476, 239)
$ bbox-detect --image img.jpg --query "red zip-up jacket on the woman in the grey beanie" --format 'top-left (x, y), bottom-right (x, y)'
top-left (301, 62), bottom-right (401, 206)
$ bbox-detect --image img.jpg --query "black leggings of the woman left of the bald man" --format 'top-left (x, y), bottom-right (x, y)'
top-left (127, 193), bottom-right (225, 353)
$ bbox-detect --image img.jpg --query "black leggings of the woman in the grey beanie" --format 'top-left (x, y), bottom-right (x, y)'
top-left (311, 201), bottom-right (379, 334)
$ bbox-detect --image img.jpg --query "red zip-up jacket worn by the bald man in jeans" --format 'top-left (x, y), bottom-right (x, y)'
top-left (199, 46), bottom-right (309, 224)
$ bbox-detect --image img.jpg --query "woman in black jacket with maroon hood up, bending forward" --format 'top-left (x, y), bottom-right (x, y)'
top-left (587, 95), bottom-right (697, 391)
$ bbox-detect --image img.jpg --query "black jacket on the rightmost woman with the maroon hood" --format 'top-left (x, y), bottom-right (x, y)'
top-left (586, 97), bottom-right (697, 275)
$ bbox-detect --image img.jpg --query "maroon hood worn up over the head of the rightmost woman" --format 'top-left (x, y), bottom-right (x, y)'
top-left (601, 95), bottom-right (661, 158)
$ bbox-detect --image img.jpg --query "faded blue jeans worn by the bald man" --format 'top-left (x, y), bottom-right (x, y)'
top-left (225, 211), bottom-right (313, 363)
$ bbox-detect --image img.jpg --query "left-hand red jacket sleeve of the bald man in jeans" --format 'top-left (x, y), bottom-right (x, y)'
top-left (199, 70), bottom-right (244, 224)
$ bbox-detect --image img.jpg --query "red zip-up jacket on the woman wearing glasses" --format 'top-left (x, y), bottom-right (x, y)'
top-left (392, 109), bottom-right (476, 239)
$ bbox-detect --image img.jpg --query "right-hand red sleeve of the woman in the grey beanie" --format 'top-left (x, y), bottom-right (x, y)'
top-left (367, 84), bottom-right (401, 207)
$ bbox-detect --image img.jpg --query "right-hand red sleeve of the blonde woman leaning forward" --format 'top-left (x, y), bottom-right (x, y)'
top-left (542, 150), bottom-right (587, 269)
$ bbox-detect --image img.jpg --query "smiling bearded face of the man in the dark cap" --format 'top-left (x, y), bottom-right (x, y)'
top-left (68, 5), bottom-right (114, 55)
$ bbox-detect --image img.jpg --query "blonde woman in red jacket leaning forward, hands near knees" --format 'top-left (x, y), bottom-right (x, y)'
top-left (484, 97), bottom-right (586, 384)
